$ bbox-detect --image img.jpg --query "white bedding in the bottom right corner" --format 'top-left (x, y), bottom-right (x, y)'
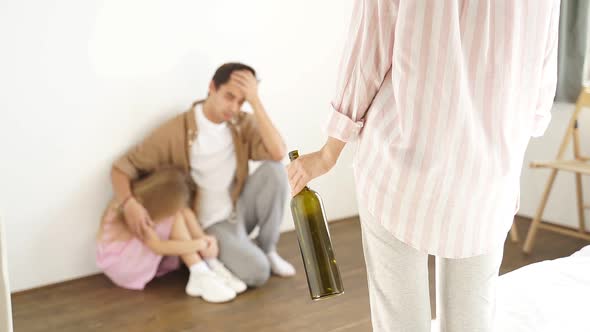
top-left (432, 246), bottom-right (590, 332)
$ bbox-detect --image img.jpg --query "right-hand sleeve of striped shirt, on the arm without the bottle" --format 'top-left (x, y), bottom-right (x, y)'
top-left (531, 1), bottom-right (559, 137)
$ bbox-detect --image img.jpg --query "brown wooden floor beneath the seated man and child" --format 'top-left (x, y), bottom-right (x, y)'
top-left (13, 218), bottom-right (588, 332)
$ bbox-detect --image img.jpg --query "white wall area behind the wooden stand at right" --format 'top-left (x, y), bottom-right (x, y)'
top-left (518, 103), bottom-right (590, 231)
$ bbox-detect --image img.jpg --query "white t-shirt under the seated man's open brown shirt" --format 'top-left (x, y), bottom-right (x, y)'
top-left (190, 105), bottom-right (236, 229)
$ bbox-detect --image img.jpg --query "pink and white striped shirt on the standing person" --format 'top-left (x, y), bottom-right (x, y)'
top-left (327, 0), bottom-right (559, 258)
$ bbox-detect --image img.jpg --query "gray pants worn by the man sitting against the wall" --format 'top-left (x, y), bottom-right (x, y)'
top-left (205, 161), bottom-right (288, 287)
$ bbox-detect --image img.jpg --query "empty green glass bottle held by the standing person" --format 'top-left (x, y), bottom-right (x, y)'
top-left (289, 150), bottom-right (344, 300)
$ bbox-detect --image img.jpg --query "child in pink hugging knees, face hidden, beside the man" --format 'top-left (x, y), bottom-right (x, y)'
top-left (96, 169), bottom-right (246, 303)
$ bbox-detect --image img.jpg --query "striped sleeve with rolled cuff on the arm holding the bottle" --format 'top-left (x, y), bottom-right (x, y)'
top-left (325, 0), bottom-right (399, 142)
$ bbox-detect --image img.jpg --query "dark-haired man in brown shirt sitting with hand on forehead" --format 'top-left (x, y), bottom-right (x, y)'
top-left (112, 63), bottom-right (295, 296)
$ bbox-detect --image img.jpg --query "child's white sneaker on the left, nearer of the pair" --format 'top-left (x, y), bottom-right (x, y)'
top-left (185, 271), bottom-right (236, 303)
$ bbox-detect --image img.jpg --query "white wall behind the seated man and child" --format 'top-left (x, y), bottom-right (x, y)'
top-left (0, 0), bottom-right (356, 291)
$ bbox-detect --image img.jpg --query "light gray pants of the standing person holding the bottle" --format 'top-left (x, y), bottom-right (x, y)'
top-left (360, 207), bottom-right (503, 332)
